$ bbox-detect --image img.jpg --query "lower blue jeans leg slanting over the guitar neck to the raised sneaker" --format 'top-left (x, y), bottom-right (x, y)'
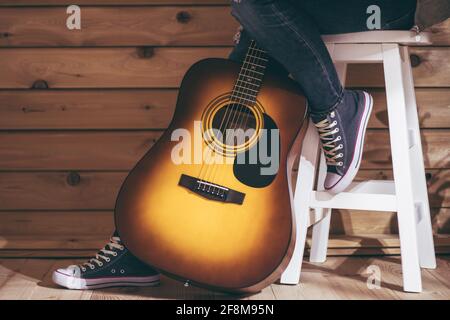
top-left (232, 0), bottom-right (343, 114)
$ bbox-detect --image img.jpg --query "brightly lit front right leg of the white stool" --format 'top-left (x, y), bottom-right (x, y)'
top-left (382, 44), bottom-right (422, 292)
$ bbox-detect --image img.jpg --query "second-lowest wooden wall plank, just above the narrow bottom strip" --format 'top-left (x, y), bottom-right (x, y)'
top-left (0, 208), bottom-right (450, 240)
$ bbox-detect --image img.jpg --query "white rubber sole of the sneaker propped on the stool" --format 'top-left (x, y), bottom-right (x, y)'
top-left (326, 92), bottom-right (373, 193)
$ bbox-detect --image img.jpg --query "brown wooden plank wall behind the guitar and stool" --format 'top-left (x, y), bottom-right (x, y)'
top-left (0, 0), bottom-right (450, 257)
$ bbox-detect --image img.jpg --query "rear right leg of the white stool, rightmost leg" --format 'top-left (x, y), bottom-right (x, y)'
top-left (401, 47), bottom-right (436, 269)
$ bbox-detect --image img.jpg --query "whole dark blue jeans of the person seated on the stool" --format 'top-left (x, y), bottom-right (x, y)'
top-left (229, 0), bottom-right (416, 115)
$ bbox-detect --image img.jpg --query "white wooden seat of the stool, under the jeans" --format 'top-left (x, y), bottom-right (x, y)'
top-left (322, 30), bottom-right (431, 45)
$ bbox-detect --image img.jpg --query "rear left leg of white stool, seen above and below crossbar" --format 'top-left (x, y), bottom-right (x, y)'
top-left (309, 152), bottom-right (331, 263)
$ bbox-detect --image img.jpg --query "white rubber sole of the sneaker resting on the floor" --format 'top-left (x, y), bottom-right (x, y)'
top-left (52, 270), bottom-right (159, 290)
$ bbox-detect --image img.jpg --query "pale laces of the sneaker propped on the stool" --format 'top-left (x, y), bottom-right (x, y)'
top-left (314, 112), bottom-right (344, 167)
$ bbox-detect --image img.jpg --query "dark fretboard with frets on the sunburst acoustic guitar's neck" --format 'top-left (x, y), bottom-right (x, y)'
top-left (231, 40), bottom-right (268, 104)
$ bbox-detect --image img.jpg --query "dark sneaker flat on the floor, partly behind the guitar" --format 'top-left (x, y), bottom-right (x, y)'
top-left (52, 235), bottom-right (159, 289)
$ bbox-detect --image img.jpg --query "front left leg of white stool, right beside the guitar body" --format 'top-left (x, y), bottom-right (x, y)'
top-left (280, 122), bottom-right (319, 284)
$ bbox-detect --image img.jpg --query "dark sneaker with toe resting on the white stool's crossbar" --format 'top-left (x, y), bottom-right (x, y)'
top-left (311, 90), bottom-right (373, 193)
